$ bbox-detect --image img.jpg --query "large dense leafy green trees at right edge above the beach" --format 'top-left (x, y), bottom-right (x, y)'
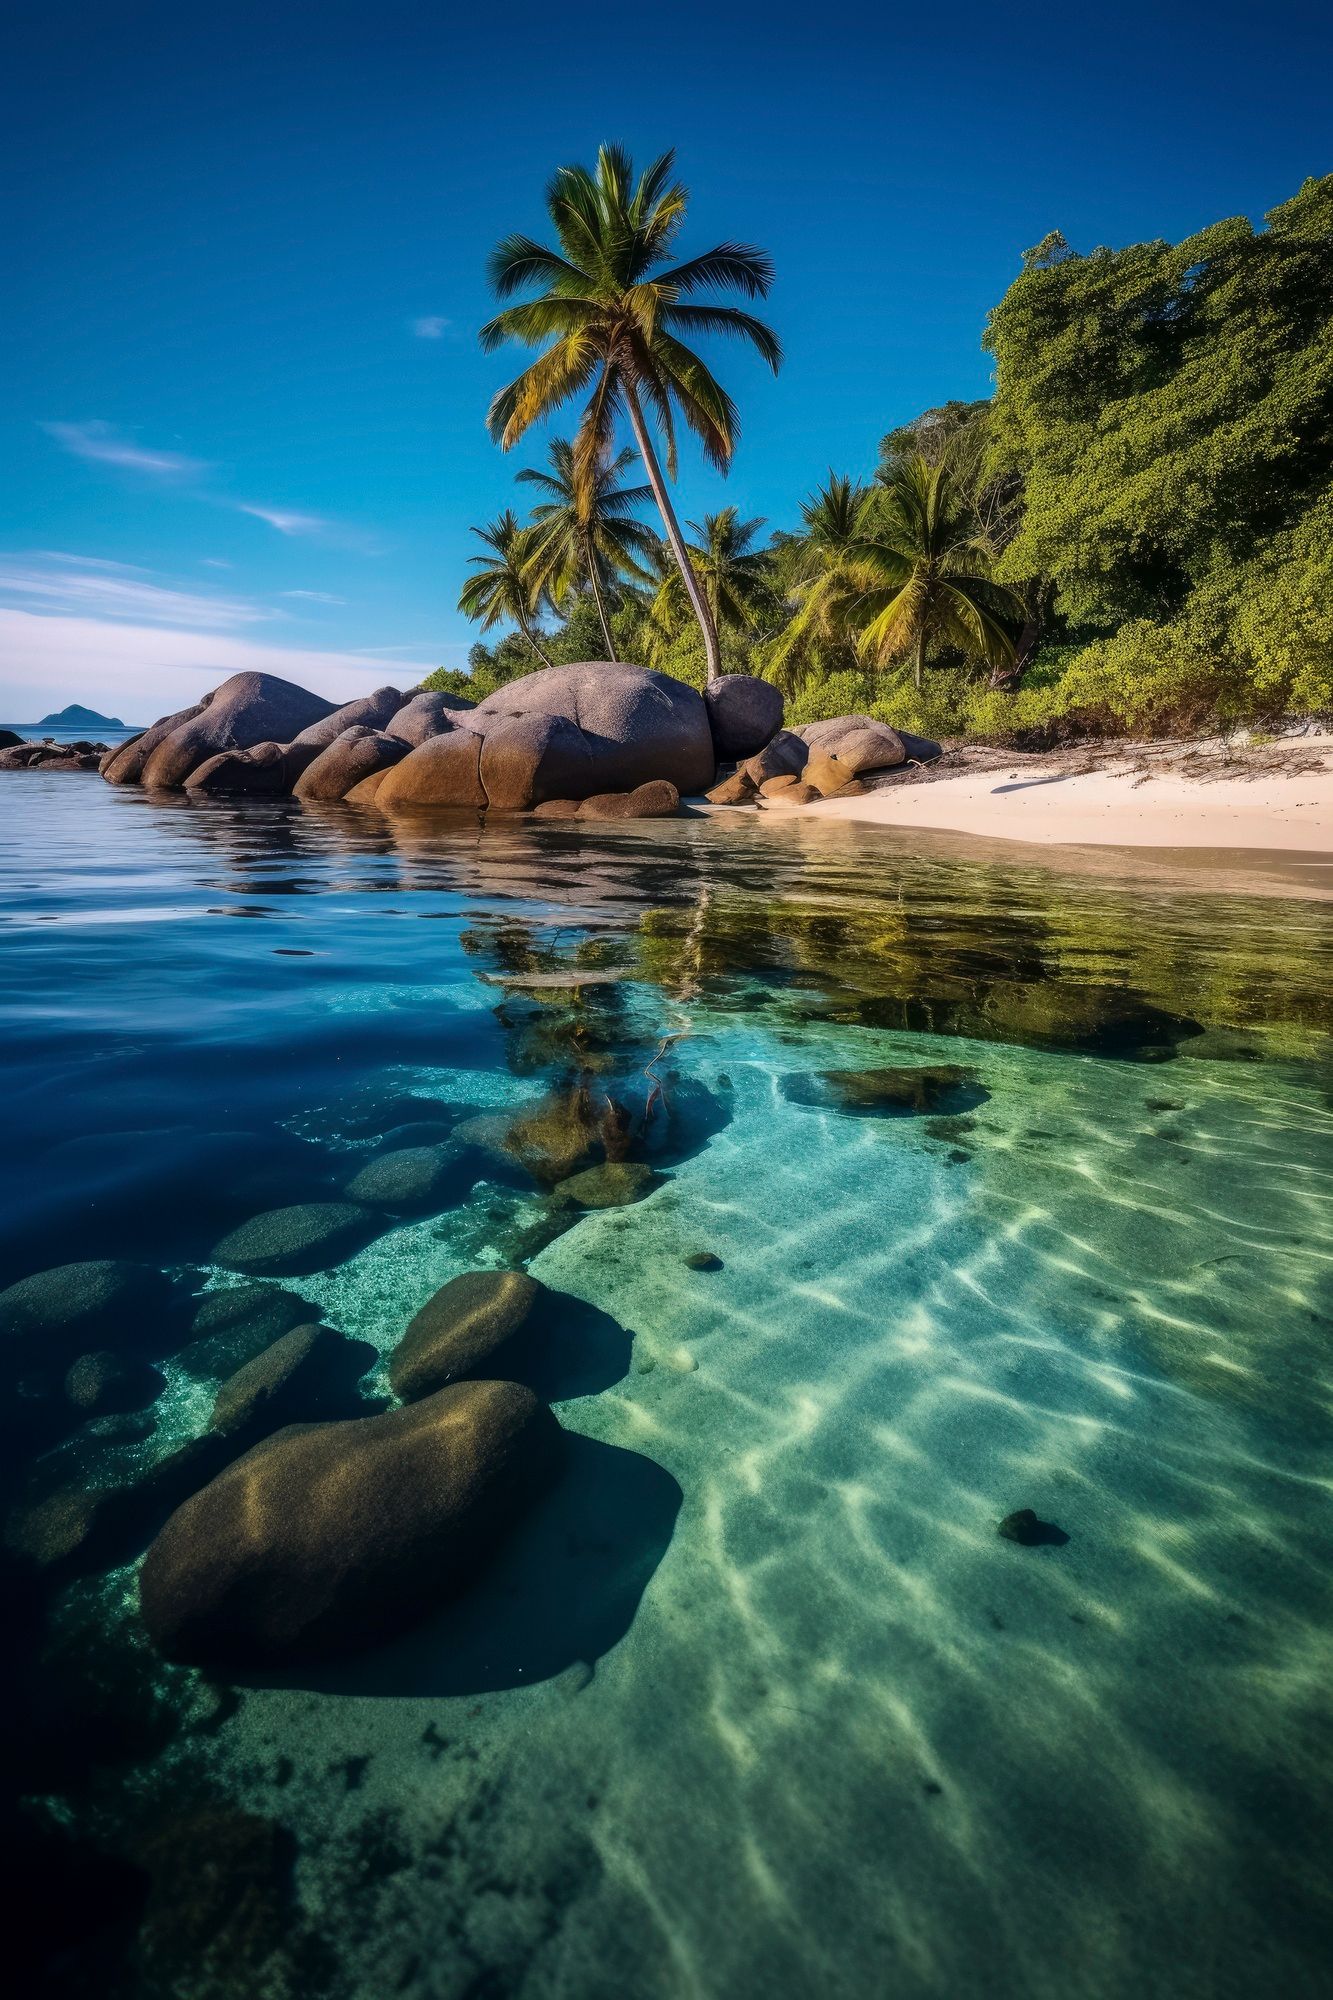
top-left (987, 176), bottom-right (1333, 728)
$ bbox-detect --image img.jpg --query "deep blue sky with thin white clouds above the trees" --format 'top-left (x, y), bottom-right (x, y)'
top-left (0, 0), bottom-right (1333, 720)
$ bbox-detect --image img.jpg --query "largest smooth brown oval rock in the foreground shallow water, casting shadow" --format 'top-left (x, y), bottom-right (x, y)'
top-left (140, 1382), bottom-right (560, 1668)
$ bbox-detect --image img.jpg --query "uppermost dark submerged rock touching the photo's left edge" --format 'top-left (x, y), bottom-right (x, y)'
top-left (0, 1258), bottom-right (172, 1370)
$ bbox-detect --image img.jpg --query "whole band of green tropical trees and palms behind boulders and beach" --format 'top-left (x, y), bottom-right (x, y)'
top-left (436, 168), bottom-right (1333, 736)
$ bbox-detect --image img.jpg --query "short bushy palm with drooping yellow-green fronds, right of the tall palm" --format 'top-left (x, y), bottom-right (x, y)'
top-left (853, 454), bottom-right (1023, 688)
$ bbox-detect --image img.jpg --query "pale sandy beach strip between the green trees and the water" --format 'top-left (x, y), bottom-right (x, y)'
top-left (765, 738), bottom-right (1333, 856)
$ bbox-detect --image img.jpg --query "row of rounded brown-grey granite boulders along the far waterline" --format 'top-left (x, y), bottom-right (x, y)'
top-left (0, 660), bottom-right (939, 820)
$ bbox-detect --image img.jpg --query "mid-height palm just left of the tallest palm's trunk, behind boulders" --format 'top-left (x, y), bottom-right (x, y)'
top-left (518, 438), bottom-right (658, 660)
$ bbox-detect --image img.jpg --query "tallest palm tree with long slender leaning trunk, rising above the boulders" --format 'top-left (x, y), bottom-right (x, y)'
top-left (480, 146), bottom-right (783, 674)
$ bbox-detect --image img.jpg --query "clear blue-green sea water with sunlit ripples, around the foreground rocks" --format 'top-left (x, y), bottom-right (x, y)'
top-left (0, 774), bottom-right (1333, 2000)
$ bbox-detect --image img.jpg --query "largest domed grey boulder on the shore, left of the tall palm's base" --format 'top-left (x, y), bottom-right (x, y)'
top-left (468, 660), bottom-right (717, 804)
